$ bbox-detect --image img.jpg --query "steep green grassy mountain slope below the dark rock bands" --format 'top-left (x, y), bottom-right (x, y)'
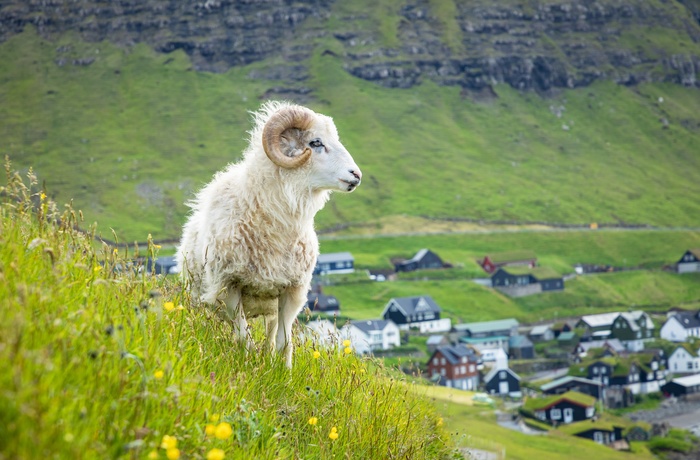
top-left (0, 27), bottom-right (700, 240)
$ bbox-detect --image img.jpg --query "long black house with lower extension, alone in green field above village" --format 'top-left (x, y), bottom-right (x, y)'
top-left (491, 267), bottom-right (564, 297)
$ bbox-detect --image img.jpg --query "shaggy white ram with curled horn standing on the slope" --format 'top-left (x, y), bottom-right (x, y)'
top-left (176, 102), bottom-right (362, 368)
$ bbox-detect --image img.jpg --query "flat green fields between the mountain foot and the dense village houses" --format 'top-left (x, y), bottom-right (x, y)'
top-left (321, 230), bottom-right (700, 322)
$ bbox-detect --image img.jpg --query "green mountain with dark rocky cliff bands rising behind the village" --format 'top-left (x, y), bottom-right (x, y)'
top-left (0, 0), bottom-right (700, 240)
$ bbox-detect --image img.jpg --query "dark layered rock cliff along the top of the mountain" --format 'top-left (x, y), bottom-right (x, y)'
top-left (0, 0), bottom-right (700, 93)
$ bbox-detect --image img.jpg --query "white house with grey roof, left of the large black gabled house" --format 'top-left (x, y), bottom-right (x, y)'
top-left (340, 319), bottom-right (401, 355)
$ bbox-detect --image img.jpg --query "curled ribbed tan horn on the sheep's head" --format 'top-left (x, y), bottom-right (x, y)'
top-left (262, 106), bottom-right (314, 169)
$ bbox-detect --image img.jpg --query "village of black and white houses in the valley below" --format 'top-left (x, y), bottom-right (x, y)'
top-left (299, 249), bottom-right (700, 450)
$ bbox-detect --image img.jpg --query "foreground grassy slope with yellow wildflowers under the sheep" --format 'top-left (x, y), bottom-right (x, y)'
top-left (0, 167), bottom-right (452, 459)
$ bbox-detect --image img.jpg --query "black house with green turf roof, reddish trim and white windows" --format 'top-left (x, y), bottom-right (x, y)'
top-left (523, 391), bottom-right (596, 425)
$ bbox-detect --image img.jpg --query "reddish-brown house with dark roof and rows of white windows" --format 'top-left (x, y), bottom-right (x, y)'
top-left (427, 345), bottom-right (479, 390)
